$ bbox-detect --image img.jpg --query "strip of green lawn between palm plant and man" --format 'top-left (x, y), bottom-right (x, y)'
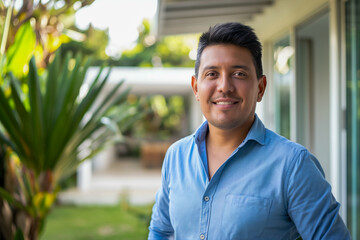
top-left (40, 204), bottom-right (152, 240)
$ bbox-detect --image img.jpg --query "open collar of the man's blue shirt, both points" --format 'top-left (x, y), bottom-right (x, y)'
top-left (193, 114), bottom-right (266, 145)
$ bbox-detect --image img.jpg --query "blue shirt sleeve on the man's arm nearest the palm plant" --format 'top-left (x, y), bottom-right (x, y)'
top-left (148, 153), bottom-right (174, 240)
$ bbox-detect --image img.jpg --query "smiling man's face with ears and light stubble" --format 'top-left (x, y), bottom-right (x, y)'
top-left (191, 44), bottom-right (266, 129)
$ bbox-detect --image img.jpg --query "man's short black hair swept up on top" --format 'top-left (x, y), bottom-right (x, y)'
top-left (195, 22), bottom-right (263, 78)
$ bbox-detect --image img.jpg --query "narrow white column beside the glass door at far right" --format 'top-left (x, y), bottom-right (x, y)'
top-left (330, 0), bottom-right (347, 221)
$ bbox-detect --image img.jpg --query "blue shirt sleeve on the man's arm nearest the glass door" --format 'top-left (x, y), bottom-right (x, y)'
top-left (287, 150), bottom-right (351, 240)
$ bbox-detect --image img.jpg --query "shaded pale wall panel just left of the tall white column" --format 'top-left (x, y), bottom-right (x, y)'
top-left (297, 13), bottom-right (330, 180)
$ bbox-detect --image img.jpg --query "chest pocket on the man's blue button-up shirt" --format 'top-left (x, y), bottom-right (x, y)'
top-left (221, 195), bottom-right (272, 239)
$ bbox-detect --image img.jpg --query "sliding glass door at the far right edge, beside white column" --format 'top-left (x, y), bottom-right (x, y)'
top-left (345, 0), bottom-right (360, 239)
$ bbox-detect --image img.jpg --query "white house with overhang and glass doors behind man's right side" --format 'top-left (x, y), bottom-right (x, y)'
top-left (157, 0), bottom-right (360, 236)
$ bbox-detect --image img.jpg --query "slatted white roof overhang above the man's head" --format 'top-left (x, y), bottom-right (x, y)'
top-left (157, 0), bottom-right (274, 36)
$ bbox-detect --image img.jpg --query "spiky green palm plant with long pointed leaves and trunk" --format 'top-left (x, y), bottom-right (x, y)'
top-left (0, 51), bottom-right (129, 239)
